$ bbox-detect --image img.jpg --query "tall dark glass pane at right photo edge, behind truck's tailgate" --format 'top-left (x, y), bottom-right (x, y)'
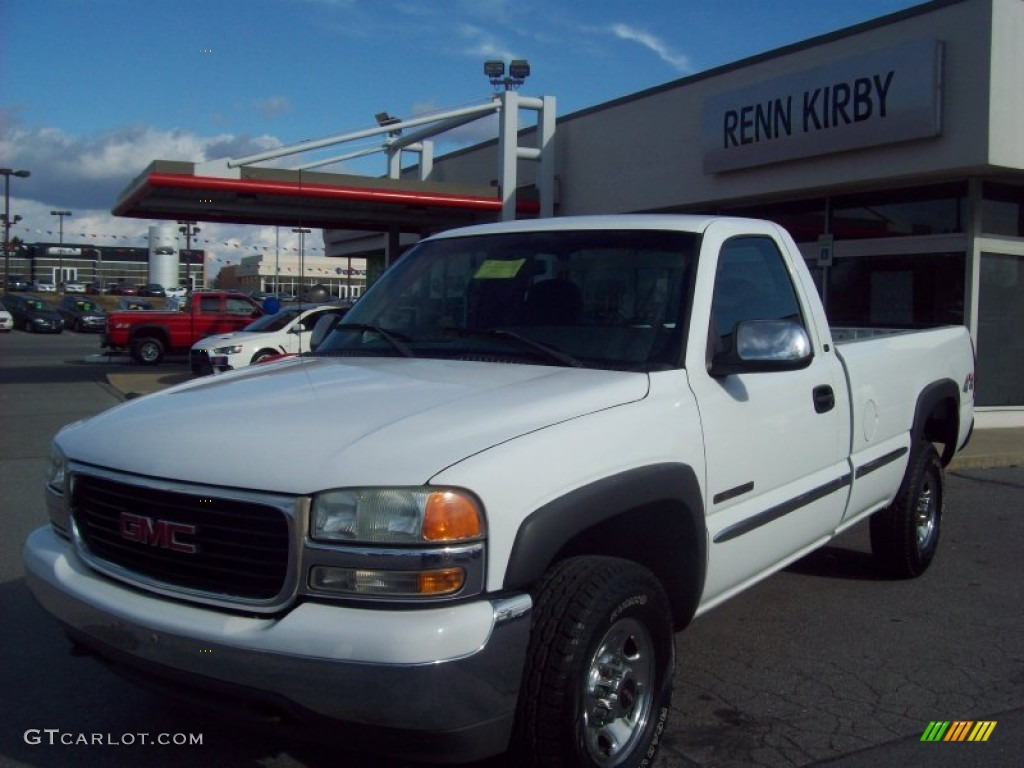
top-left (976, 253), bottom-right (1024, 406)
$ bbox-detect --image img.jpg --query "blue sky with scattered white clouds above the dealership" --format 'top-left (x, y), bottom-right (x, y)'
top-left (0, 0), bottom-right (922, 260)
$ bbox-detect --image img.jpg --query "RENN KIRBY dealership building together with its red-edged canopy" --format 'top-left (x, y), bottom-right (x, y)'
top-left (108, 0), bottom-right (1024, 426)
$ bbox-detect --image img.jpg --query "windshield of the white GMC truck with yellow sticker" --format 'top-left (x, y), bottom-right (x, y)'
top-left (316, 229), bottom-right (697, 371)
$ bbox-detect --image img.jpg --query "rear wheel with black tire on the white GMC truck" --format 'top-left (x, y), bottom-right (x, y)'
top-left (870, 440), bottom-right (944, 579)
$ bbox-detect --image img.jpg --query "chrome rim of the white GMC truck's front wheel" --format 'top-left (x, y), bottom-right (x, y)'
top-left (584, 618), bottom-right (655, 766)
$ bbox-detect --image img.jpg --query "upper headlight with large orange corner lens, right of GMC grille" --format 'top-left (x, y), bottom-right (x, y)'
top-left (310, 488), bottom-right (484, 544)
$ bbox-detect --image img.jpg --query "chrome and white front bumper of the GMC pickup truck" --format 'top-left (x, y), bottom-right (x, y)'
top-left (24, 526), bottom-right (531, 760)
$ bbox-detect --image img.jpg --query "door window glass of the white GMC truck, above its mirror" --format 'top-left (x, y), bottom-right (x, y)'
top-left (711, 237), bottom-right (804, 351)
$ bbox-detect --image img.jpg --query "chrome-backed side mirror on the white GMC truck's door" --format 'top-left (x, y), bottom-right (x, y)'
top-left (709, 319), bottom-right (814, 377)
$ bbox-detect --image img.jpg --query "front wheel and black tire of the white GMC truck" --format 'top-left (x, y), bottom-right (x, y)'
top-left (513, 557), bottom-right (675, 768)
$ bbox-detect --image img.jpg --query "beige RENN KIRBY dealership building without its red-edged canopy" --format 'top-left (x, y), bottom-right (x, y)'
top-left (387, 0), bottom-right (1024, 426)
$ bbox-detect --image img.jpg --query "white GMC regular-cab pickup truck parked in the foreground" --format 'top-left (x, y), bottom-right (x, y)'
top-left (25, 215), bottom-right (974, 766)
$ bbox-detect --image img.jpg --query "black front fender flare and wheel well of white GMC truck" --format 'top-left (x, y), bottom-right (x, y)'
top-left (504, 463), bottom-right (708, 628)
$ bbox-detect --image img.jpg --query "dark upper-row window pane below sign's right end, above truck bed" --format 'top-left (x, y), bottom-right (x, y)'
top-left (829, 183), bottom-right (967, 240)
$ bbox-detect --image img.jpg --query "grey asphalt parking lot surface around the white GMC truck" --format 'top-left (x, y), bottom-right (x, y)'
top-left (0, 333), bottom-right (1024, 768)
